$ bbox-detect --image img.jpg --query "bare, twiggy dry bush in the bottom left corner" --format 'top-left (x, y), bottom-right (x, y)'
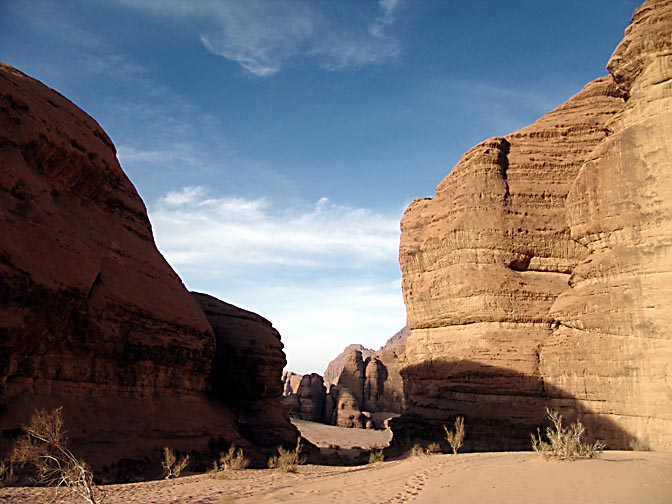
top-left (11, 408), bottom-right (105, 504)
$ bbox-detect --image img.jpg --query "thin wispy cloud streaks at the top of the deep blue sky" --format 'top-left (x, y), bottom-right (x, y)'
top-left (117, 0), bottom-right (401, 77)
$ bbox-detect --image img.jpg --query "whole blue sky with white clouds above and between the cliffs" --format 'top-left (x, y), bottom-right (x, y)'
top-left (0, 0), bottom-right (638, 372)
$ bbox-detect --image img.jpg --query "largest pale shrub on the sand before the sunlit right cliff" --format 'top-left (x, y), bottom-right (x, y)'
top-left (530, 408), bottom-right (606, 460)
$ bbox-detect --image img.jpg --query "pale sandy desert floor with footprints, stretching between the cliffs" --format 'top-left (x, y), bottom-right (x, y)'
top-left (0, 425), bottom-right (672, 504)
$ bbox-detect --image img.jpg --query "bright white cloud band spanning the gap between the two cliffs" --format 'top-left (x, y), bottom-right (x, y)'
top-left (150, 187), bottom-right (399, 268)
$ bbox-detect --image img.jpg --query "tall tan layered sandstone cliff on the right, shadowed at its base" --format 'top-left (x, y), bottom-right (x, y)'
top-left (400, 0), bottom-right (672, 450)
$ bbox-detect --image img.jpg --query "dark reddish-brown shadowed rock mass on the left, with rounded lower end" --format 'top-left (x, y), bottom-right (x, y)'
top-left (0, 64), bottom-right (296, 479)
